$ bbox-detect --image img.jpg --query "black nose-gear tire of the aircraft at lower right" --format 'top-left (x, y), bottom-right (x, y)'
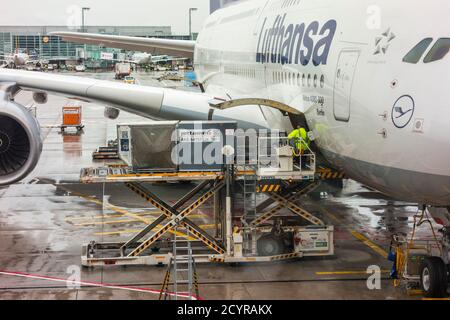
top-left (420, 257), bottom-right (448, 298)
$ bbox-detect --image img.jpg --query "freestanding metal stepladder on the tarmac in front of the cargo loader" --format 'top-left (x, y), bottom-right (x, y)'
top-left (159, 227), bottom-right (199, 300)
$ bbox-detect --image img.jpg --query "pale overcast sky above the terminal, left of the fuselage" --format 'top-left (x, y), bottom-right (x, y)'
top-left (0, 0), bottom-right (209, 34)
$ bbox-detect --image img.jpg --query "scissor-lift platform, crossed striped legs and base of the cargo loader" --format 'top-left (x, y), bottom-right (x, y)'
top-left (80, 161), bottom-right (341, 267)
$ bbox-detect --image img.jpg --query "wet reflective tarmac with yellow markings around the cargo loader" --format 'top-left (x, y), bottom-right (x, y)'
top-left (0, 73), bottom-right (436, 300)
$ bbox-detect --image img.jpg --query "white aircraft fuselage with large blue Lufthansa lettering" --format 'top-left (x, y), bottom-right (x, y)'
top-left (195, 0), bottom-right (450, 206)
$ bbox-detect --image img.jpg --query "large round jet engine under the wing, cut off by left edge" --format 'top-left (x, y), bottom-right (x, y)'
top-left (0, 93), bottom-right (42, 185)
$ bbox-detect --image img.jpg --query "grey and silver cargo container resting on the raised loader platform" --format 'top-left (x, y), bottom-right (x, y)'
top-left (117, 121), bottom-right (237, 172)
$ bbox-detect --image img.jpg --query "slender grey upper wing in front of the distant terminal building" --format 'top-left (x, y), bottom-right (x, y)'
top-left (50, 31), bottom-right (195, 58)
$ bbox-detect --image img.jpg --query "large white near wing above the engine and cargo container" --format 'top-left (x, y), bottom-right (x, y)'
top-left (0, 69), bottom-right (214, 120)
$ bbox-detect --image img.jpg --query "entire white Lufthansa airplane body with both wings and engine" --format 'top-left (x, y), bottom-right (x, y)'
top-left (0, 0), bottom-right (450, 207)
